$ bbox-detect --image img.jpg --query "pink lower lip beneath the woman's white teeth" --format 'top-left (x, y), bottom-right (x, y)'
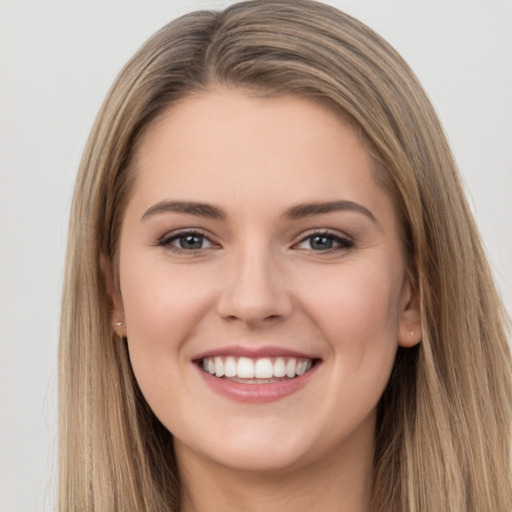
top-left (197, 364), bottom-right (320, 403)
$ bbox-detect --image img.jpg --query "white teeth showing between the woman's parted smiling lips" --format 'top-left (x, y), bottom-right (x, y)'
top-left (197, 356), bottom-right (319, 384)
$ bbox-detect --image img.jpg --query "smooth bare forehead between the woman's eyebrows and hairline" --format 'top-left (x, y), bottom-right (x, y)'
top-left (127, 89), bottom-right (396, 228)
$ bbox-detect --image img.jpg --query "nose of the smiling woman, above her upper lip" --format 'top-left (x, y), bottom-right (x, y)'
top-left (217, 241), bottom-right (293, 328)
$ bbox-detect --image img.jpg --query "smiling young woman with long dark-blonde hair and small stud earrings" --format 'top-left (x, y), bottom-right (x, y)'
top-left (60, 0), bottom-right (512, 512)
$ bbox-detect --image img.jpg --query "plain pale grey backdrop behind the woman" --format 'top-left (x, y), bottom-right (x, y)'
top-left (0, 0), bottom-right (512, 512)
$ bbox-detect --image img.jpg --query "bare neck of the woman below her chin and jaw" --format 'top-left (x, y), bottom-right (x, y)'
top-left (176, 434), bottom-right (373, 512)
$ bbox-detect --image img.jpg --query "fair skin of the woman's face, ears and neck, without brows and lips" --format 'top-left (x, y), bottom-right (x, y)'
top-left (113, 89), bottom-right (419, 512)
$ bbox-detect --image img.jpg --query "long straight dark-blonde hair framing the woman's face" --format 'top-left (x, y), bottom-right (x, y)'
top-left (59, 0), bottom-right (512, 512)
